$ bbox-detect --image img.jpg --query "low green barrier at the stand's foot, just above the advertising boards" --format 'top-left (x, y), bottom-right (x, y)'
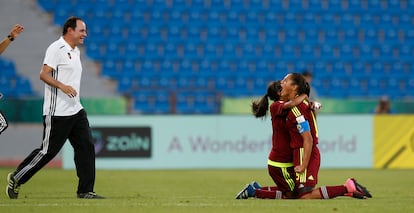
top-left (0, 97), bottom-right (414, 123)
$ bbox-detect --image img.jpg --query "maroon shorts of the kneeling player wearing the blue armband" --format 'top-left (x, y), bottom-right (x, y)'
top-left (293, 145), bottom-right (321, 196)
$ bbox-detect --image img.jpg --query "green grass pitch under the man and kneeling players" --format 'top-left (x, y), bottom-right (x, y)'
top-left (0, 168), bottom-right (414, 213)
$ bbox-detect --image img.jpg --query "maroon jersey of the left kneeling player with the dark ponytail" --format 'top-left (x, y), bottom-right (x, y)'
top-left (269, 101), bottom-right (293, 163)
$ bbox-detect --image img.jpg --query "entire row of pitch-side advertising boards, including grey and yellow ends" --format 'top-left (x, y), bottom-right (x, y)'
top-left (0, 114), bottom-right (408, 169)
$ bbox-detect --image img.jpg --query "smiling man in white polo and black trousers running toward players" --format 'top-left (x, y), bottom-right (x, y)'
top-left (6, 17), bottom-right (103, 199)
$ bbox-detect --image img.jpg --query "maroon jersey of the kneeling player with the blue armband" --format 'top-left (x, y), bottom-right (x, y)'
top-left (286, 101), bottom-right (318, 149)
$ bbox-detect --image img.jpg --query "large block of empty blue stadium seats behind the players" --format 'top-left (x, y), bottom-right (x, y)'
top-left (38, 0), bottom-right (414, 114)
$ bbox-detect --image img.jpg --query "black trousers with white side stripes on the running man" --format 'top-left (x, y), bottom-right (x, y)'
top-left (14, 109), bottom-right (95, 193)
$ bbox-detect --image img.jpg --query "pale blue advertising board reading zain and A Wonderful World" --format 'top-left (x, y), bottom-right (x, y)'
top-left (62, 115), bottom-right (374, 169)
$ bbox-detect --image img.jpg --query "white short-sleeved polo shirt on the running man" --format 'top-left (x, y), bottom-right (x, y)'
top-left (43, 37), bottom-right (83, 116)
